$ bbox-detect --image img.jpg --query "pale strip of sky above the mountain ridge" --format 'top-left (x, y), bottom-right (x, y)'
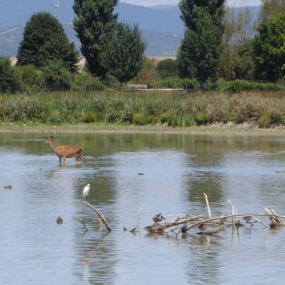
top-left (120, 0), bottom-right (261, 7)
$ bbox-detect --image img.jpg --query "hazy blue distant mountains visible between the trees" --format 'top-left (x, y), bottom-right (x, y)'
top-left (0, 0), bottom-right (260, 56)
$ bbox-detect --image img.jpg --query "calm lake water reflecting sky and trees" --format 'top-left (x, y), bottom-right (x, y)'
top-left (0, 130), bottom-right (285, 285)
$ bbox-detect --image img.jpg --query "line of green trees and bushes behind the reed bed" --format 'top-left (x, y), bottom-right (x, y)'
top-left (0, 0), bottom-right (285, 93)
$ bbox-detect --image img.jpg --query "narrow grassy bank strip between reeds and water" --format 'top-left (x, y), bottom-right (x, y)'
top-left (0, 123), bottom-right (285, 136)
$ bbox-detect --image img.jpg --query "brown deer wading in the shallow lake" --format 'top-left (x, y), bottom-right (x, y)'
top-left (44, 136), bottom-right (86, 163)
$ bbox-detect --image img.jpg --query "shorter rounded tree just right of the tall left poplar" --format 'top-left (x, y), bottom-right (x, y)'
top-left (103, 23), bottom-right (146, 86)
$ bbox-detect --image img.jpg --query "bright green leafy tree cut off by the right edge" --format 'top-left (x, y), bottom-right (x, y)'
top-left (252, 12), bottom-right (285, 81)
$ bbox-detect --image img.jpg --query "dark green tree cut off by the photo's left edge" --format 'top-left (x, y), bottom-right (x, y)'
top-left (0, 56), bottom-right (13, 93)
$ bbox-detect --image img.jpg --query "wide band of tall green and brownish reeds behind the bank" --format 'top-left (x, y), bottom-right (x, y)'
top-left (0, 91), bottom-right (285, 127)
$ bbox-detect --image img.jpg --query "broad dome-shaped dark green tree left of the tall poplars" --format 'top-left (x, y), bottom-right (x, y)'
top-left (17, 12), bottom-right (78, 72)
